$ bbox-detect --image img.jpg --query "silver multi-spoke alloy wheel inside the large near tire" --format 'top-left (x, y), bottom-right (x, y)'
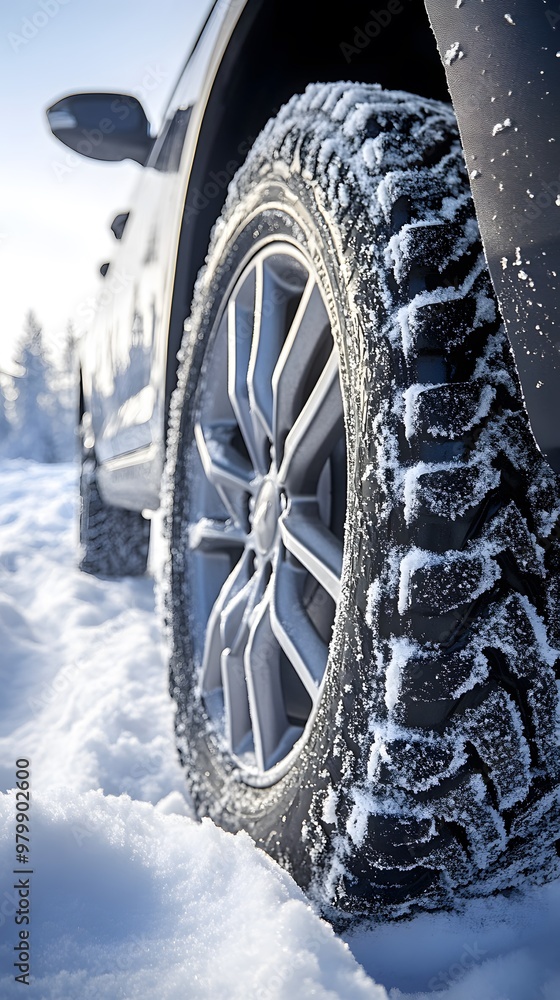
top-left (188, 241), bottom-right (346, 784)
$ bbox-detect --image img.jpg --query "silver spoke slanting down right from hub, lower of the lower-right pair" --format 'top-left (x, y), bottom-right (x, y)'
top-left (270, 559), bottom-right (328, 703)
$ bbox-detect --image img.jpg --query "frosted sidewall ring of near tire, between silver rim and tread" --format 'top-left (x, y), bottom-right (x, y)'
top-left (171, 177), bottom-right (382, 870)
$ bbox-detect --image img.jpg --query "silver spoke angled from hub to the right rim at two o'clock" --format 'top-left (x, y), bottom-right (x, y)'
top-left (278, 348), bottom-right (344, 496)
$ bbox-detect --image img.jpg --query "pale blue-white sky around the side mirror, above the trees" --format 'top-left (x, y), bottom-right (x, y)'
top-left (0, 0), bottom-right (206, 369)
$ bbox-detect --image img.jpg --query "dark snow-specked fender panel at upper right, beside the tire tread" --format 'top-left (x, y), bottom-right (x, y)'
top-left (425, 0), bottom-right (560, 472)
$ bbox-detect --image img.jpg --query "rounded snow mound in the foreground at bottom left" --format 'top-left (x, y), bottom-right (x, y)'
top-left (0, 790), bottom-right (380, 1000)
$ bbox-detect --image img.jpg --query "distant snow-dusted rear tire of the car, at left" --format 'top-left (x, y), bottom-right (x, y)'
top-left (80, 458), bottom-right (150, 577)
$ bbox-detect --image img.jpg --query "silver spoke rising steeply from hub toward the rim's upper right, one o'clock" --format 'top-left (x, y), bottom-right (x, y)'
top-left (272, 278), bottom-right (329, 465)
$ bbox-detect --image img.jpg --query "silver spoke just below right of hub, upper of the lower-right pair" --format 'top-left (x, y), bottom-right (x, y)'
top-left (280, 501), bottom-right (342, 602)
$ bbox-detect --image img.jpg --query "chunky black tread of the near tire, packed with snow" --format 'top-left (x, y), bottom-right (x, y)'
top-left (166, 83), bottom-right (560, 919)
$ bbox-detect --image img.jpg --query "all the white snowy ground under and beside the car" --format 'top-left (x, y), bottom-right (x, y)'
top-left (0, 461), bottom-right (560, 1000)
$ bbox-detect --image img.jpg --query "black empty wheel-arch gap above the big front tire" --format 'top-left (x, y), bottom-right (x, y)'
top-left (166, 0), bottom-right (449, 429)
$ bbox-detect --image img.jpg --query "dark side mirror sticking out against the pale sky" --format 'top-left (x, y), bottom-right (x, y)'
top-left (47, 94), bottom-right (154, 166)
